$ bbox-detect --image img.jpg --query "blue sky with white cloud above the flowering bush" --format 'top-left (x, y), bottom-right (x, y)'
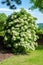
top-left (0, 0), bottom-right (43, 23)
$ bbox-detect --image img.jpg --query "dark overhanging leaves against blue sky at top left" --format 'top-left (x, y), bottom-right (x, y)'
top-left (2, 0), bottom-right (21, 9)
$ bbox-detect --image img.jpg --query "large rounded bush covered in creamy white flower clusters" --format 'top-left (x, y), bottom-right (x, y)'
top-left (4, 9), bottom-right (37, 51)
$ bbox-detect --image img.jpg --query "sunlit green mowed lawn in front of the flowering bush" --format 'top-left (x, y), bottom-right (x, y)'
top-left (0, 46), bottom-right (43, 65)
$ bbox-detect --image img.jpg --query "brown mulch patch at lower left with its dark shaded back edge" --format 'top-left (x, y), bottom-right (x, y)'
top-left (0, 48), bottom-right (14, 62)
